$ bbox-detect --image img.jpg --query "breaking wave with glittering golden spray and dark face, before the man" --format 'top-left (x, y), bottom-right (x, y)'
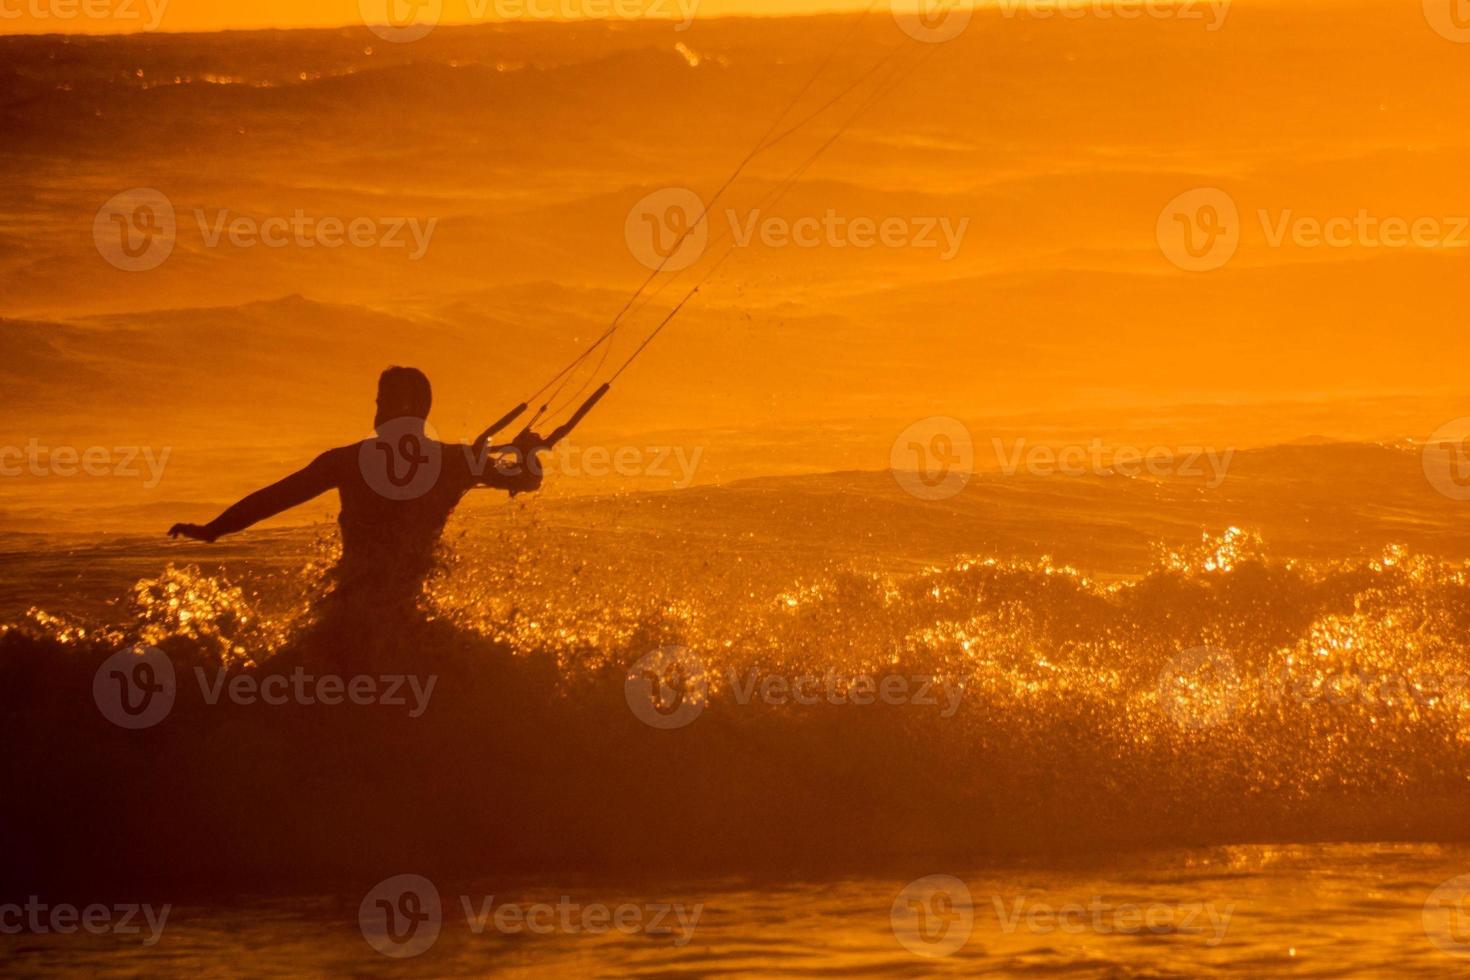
top-left (0, 526), bottom-right (1470, 887)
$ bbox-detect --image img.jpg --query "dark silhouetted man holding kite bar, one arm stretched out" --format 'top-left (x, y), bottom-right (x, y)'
top-left (169, 367), bottom-right (541, 613)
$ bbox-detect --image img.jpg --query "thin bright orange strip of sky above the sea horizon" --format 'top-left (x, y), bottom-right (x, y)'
top-left (0, 0), bottom-right (882, 34)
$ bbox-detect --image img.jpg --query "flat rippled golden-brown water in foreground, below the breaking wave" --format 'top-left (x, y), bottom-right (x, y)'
top-left (0, 843), bottom-right (1470, 980)
